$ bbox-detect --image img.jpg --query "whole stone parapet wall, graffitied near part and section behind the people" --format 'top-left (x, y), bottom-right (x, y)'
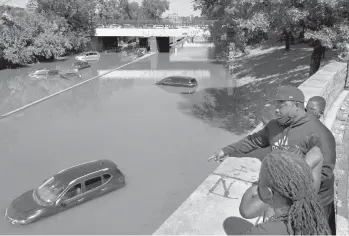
top-left (154, 62), bottom-right (347, 235)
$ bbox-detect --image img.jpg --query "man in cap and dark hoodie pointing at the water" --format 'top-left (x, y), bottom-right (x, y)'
top-left (209, 86), bottom-right (336, 232)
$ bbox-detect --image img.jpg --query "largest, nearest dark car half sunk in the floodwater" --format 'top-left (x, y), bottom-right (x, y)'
top-left (5, 160), bottom-right (126, 225)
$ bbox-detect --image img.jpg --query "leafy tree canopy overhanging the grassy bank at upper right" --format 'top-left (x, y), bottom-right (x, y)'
top-left (193, 0), bottom-right (349, 75)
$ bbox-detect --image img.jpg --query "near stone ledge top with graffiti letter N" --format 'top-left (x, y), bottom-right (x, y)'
top-left (154, 157), bottom-right (261, 235)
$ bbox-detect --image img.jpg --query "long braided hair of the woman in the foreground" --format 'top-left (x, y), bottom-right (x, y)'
top-left (261, 150), bottom-right (331, 235)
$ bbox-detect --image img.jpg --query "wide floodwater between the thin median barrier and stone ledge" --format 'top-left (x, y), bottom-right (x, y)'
top-left (0, 38), bottom-right (253, 234)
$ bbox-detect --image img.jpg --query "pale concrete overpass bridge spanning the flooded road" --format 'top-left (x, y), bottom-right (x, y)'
top-left (92, 28), bottom-right (203, 52)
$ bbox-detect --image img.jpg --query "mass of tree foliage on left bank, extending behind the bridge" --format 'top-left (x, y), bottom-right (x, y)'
top-left (0, 0), bottom-right (169, 69)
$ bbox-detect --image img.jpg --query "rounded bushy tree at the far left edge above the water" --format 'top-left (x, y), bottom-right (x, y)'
top-left (0, 7), bottom-right (71, 65)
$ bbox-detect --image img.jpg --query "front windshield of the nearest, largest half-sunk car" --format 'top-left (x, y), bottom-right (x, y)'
top-left (36, 177), bottom-right (65, 204)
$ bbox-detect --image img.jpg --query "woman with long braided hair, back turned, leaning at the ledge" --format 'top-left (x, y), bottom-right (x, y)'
top-left (241, 150), bottom-right (331, 235)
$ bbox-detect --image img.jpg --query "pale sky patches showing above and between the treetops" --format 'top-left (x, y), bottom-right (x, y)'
top-left (4, 0), bottom-right (200, 16)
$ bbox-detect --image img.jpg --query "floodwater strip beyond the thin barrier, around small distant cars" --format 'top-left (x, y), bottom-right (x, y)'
top-left (0, 49), bottom-right (135, 115)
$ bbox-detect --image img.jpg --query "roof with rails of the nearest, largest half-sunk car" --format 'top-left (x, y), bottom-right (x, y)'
top-left (54, 159), bottom-right (117, 184)
